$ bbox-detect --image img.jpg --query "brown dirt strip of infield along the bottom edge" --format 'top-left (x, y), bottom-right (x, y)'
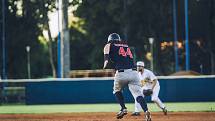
top-left (0, 112), bottom-right (215, 121)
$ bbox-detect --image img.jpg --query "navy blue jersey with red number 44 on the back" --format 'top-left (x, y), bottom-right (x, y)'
top-left (109, 42), bottom-right (135, 70)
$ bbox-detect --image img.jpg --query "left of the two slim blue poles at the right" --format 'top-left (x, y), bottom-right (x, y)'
top-left (173, 0), bottom-right (179, 72)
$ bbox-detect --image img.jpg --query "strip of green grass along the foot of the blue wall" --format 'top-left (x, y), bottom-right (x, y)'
top-left (0, 102), bottom-right (215, 114)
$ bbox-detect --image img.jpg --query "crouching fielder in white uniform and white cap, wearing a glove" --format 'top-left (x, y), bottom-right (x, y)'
top-left (132, 61), bottom-right (167, 116)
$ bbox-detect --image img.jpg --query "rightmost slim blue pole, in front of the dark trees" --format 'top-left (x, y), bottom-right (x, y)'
top-left (184, 0), bottom-right (190, 71)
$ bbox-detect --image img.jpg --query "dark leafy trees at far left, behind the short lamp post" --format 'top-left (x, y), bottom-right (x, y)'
top-left (1, 0), bottom-right (54, 78)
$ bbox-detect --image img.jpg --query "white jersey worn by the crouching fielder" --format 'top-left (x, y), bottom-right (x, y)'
top-left (139, 69), bottom-right (158, 89)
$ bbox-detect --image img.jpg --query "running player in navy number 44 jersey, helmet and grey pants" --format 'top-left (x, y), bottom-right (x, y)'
top-left (103, 33), bottom-right (151, 121)
